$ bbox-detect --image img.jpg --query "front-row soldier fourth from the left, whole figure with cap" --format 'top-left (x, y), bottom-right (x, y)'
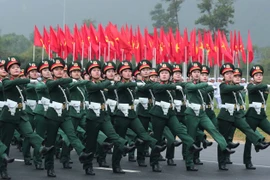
top-left (112, 61), bottom-right (166, 173)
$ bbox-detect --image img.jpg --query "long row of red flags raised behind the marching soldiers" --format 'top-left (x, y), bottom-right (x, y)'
top-left (34, 23), bottom-right (254, 66)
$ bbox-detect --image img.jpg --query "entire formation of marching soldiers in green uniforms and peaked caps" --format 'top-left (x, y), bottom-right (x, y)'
top-left (0, 56), bottom-right (270, 179)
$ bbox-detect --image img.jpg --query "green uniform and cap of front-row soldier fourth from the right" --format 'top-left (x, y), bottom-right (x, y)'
top-left (150, 63), bottom-right (195, 172)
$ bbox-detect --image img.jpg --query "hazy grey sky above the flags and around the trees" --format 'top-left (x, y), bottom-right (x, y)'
top-left (0, 0), bottom-right (270, 47)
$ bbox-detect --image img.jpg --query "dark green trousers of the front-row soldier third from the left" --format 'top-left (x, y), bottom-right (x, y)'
top-left (83, 117), bottom-right (127, 169)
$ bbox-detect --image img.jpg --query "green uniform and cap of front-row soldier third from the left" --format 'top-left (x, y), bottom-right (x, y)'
top-left (83, 60), bottom-right (130, 175)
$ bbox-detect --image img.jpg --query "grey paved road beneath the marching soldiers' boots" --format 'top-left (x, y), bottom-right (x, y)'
top-left (4, 143), bottom-right (270, 180)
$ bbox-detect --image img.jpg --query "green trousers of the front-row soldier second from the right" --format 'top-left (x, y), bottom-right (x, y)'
top-left (218, 118), bottom-right (261, 165)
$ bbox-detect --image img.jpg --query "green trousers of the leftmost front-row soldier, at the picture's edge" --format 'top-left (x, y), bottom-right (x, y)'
top-left (0, 119), bottom-right (43, 171)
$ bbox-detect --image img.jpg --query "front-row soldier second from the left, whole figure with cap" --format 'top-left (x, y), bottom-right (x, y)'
top-left (45, 58), bottom-right (91, 177)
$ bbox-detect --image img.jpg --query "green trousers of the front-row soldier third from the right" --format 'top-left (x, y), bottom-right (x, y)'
top-left (186, 113), bottom-right (227, 166)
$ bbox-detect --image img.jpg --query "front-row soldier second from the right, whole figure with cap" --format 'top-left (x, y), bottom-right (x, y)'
top-left (218, 63), bottom-right (269, 171)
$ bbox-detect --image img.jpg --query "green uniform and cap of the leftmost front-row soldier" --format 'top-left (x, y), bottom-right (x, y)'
top-left (0, 56), bottom-right (43, 177)
